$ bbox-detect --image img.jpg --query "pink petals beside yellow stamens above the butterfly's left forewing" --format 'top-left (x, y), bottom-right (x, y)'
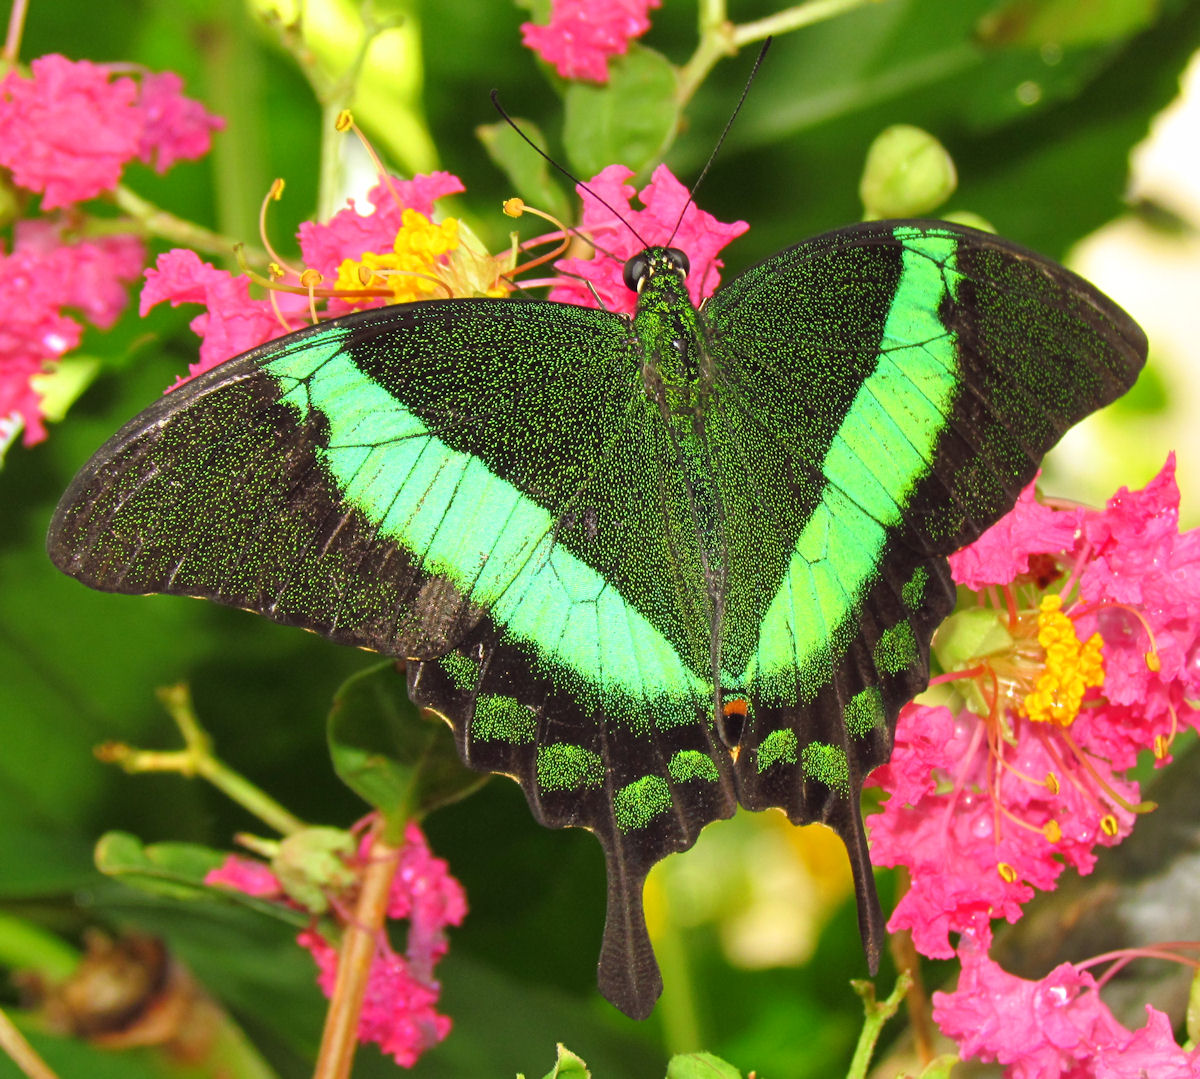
top-left (140, 173), bottom-right (463, 386)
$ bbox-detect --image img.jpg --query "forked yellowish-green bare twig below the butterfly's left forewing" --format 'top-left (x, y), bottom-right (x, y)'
top-left (96, 685), bottom-right (307, 835)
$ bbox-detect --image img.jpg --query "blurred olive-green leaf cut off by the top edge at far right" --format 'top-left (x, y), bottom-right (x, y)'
top-left (977, 0), bottom-right (1159, 48)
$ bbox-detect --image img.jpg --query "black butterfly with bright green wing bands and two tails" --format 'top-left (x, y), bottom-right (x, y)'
top-left (48, 221), bottom-right (1146, 1018)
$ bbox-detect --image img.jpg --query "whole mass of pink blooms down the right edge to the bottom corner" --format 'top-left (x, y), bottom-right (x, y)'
top-left (868, 456), bottom-right (1200, 1079)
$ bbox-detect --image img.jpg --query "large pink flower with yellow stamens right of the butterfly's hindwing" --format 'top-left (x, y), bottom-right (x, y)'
top-left (868, 460), bottom-right (1200, 958)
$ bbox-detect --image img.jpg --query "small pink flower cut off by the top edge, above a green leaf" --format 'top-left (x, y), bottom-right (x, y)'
top-left (521, 0), bottom-right (662, 83)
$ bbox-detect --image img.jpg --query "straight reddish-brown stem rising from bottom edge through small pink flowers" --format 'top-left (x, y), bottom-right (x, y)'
top-left (313, 820), bottom-right (400, 1079)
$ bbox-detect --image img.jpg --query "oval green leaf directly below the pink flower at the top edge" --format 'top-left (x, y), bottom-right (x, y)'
top-left (563, 44), bottom-right (679, 179)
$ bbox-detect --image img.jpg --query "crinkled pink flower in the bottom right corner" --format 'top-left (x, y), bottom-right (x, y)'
top-left (934, 936), bottom-right (1200, 1079)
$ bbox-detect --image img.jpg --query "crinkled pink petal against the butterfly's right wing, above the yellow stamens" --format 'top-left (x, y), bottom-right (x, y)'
top-left (949, 479), bottom-right (1082, 592)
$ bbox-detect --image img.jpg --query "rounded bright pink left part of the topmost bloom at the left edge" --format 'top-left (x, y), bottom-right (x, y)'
top-left (0, 54), bottom-right (143, 210)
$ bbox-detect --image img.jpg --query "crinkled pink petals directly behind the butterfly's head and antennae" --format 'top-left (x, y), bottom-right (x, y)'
top-left (550, 164), bottom-right (750, 312)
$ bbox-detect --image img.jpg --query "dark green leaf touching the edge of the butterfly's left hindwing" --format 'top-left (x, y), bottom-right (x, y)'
top-left (326, 660), bottom-right (487, 827)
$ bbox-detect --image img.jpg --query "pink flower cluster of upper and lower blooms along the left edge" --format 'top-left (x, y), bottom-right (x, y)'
top-left (0, 55), bottom-right (223, 445)
